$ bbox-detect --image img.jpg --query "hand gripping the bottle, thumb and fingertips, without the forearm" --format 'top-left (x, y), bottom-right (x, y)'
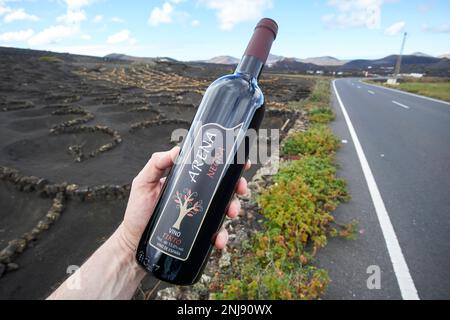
top-left (119, 147), bottom-right (250, 252)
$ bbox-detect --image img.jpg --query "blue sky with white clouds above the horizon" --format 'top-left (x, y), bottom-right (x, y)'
top-left (0, 0), bottom-right (450, 60)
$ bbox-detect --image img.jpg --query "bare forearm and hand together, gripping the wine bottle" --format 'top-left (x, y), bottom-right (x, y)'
top-left (48, 147), bottom-right (250, 300)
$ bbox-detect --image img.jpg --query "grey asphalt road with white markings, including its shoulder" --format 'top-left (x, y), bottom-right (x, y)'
top-left (318, 79), bottom-right (450, 299)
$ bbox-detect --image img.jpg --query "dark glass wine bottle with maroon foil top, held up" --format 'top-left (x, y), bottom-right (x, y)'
top-left (136, 18), bottom-right (278, 285)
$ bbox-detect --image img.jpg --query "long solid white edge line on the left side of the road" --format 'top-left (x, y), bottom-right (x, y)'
top-left (333, 80), bottom-right (419, 300)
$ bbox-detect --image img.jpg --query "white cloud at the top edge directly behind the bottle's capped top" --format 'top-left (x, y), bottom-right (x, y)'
top-left (201, 0), bottom-right (272, 30)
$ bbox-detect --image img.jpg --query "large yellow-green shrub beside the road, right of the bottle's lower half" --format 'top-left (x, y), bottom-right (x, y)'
top-left (258, 156), bottom-right (349, 248)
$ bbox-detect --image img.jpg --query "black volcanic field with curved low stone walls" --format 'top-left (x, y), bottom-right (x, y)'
top-left (0, 48), bottom-right (311, 299)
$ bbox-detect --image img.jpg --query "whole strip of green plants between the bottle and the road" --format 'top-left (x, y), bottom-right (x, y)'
top-left (210, 80), bottom-right (356, 299)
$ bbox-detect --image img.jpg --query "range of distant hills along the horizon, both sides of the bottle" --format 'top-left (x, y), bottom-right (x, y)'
top-left (0, 47), bottom-right (450, 77)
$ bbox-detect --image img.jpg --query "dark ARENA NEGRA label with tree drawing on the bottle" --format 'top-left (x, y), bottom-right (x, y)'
top-left (149, 123), bottom-right (243, 261)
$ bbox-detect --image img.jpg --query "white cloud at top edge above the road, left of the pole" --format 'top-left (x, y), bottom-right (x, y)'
top-left (322, 0), bottom-right (385, 29)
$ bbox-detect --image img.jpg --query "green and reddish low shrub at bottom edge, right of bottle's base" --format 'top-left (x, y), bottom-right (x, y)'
top-left (213, 228), bottom-right (329, 300)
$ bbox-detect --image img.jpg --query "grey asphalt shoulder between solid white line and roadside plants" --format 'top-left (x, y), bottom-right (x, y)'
top-left (318, 80), bottom-right (401, 299)
